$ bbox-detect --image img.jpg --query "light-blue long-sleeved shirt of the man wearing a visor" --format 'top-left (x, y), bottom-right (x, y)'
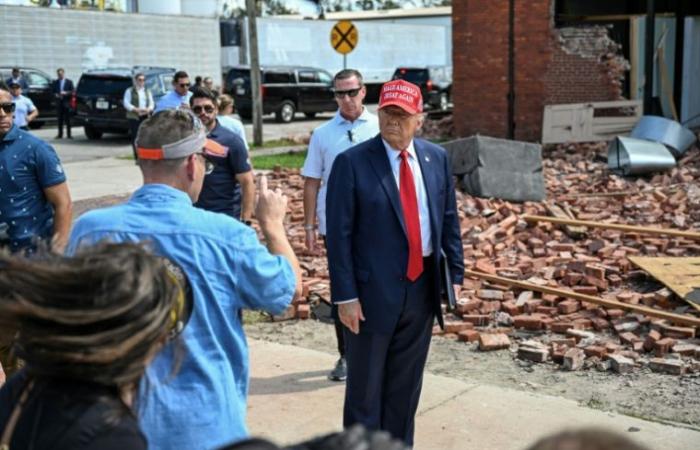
top-left (68, 184), bottom-right (295, 450)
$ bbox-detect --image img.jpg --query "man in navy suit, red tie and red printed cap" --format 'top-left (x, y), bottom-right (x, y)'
top-left (326, 80), bottom-right (464, 445)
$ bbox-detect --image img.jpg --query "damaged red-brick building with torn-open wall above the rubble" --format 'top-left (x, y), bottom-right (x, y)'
top-left (452, 0), bottom-right (700, 141)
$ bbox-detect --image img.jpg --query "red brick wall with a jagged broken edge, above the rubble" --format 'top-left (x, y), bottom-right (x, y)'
top-left (452, 0), bottom-right (624, 141)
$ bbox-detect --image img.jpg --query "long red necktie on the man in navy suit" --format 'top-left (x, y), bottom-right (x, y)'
top-left (399, 150), bottom-right (423, 281)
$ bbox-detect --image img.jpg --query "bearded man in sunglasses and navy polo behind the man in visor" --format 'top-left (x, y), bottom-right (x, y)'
top-left (190, 88), bottom-right (255, 221)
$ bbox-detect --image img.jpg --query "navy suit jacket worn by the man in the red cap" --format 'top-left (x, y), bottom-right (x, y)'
top-left (326, 135), bottom-right (464, 334)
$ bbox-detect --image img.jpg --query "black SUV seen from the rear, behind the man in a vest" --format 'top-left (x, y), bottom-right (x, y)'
top-left (73, 66), bottom-right (175, 139)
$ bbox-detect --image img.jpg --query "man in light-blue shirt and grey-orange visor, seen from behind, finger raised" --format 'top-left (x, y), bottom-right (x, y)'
top-left (69, 110), bottom-right (301, 450)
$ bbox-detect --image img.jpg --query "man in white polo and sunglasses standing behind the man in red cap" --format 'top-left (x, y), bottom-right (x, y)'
top-left (301, 69), bottom-right (379, 381)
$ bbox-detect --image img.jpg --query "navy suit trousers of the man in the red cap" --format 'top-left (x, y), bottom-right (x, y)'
top-left (343, 260), bottom-right (435, 446)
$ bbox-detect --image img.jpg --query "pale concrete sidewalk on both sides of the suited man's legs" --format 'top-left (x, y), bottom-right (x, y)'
top-left (248, 340), bottom-right (700, 450)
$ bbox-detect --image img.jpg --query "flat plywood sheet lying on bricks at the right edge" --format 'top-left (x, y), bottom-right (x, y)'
top-left (629, 256), bottom-right (700, 310)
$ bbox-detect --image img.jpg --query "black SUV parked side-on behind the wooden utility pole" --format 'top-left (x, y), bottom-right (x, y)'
top-left (224, 66), bottom-right (338, 123)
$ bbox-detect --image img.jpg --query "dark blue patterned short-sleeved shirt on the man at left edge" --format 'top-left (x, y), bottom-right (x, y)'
top-left (0, 125), bottom-right (66, 252)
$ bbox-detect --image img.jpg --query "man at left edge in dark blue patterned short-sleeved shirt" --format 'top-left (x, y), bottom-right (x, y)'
top-left (0, 90), bottom-right (72, 253)
